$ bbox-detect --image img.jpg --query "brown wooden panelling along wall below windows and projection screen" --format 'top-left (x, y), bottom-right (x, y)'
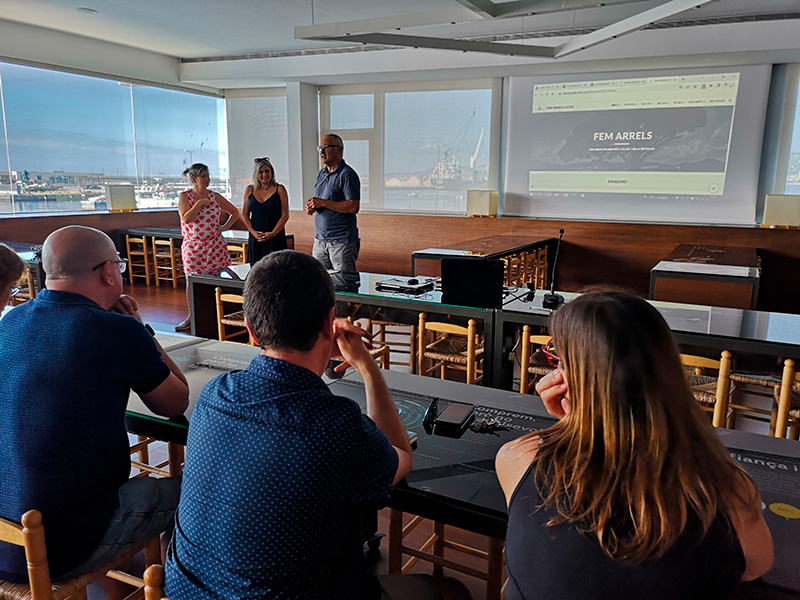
top-left (6, 210), bottom-right (800, 313)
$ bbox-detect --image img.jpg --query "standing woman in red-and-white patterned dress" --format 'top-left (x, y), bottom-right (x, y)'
top-left (175, 163), bottom-right (239, 331)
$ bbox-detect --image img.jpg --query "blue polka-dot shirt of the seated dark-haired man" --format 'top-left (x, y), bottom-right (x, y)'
top-left (166, 355), bottom-right (398, 600)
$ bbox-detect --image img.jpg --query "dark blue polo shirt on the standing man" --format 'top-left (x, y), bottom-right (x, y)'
top-left (314, 161), bottom-right (361, 242)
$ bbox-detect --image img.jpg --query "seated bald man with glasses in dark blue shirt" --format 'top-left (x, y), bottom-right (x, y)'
top-left (0, 226), bottom-right (189, 582)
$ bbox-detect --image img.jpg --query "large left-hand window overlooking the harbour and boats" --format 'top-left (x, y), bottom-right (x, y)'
top-left (0, 64), bottom-right (228, 213)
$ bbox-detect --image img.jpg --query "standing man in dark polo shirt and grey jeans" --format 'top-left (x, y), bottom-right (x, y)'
top-left (306, 133), bottom-right (361, 273)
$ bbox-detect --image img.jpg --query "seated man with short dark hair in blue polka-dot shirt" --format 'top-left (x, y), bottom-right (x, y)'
top-left (166, 250), bottom-right (468, 600)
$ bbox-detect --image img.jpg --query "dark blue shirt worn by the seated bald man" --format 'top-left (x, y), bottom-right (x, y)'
top-left (0, 290), bottom-right (169, 581)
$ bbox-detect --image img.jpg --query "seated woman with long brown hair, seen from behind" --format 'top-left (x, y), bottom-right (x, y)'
top-left (497, 292), bottom-right (772, 600)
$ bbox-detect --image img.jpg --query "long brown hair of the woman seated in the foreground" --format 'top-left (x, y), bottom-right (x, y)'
top-left (526, 292), bottom-right (755, 564)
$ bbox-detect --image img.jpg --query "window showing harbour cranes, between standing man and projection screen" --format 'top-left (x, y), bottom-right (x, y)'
top-left (320, 80), bottom-right (500, 214)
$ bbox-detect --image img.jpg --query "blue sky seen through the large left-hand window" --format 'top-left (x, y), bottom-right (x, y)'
top-left (0, 64), bottom-right (227, 176)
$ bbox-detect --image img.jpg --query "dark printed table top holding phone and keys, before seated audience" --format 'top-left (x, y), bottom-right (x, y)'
top-left (127, 336), bottom-right (800, 591)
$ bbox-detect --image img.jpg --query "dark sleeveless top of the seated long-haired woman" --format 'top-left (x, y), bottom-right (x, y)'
top-left (506, 466), bottom-right (745, 600)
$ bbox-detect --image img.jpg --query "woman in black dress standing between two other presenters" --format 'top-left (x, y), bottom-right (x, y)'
top-left (242, 157), bottom-right (289, 265)
